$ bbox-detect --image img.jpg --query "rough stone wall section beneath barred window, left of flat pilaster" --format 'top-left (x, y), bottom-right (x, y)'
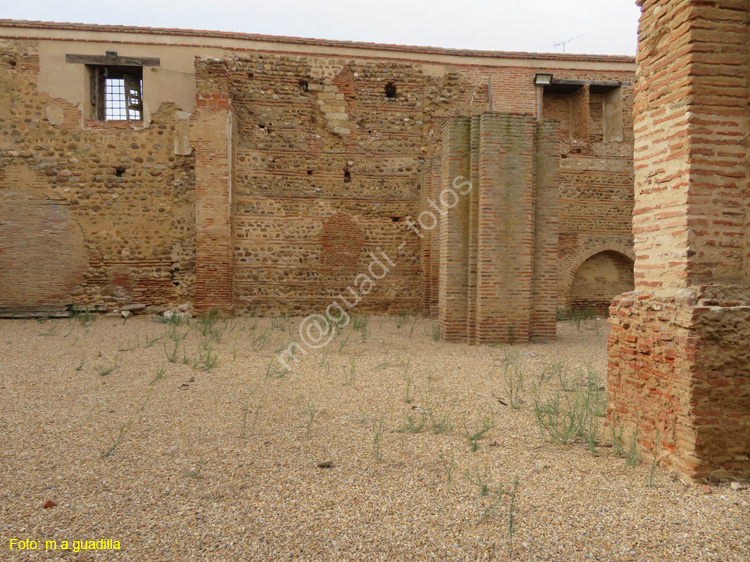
top-left (0, 41), bottom-right (195, 314)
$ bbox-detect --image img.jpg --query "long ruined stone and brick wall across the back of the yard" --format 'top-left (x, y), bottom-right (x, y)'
top-left (0, 24), bottom-right (632, 318)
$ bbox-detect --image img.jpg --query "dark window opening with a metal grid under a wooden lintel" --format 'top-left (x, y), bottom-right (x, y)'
top-left (89, 65), bottom-right (143, 121)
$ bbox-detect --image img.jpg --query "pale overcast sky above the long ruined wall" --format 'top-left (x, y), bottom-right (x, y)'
top-left (0, 0), bottom-right (640, 55)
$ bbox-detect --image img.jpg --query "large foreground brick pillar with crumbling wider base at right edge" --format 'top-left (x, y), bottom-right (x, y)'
top-left (608, 0), bottom-right (750, 480)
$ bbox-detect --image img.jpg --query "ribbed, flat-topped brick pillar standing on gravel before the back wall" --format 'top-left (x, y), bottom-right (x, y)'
top-left (432, 113), bottom-right (559, 344)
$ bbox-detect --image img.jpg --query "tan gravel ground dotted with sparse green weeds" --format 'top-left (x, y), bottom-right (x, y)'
top-left (0, 317), bottom-right (750, 561)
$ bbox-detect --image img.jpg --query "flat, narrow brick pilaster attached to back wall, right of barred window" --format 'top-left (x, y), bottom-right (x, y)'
top-left (191, 60), bottom-right (236, 313)
